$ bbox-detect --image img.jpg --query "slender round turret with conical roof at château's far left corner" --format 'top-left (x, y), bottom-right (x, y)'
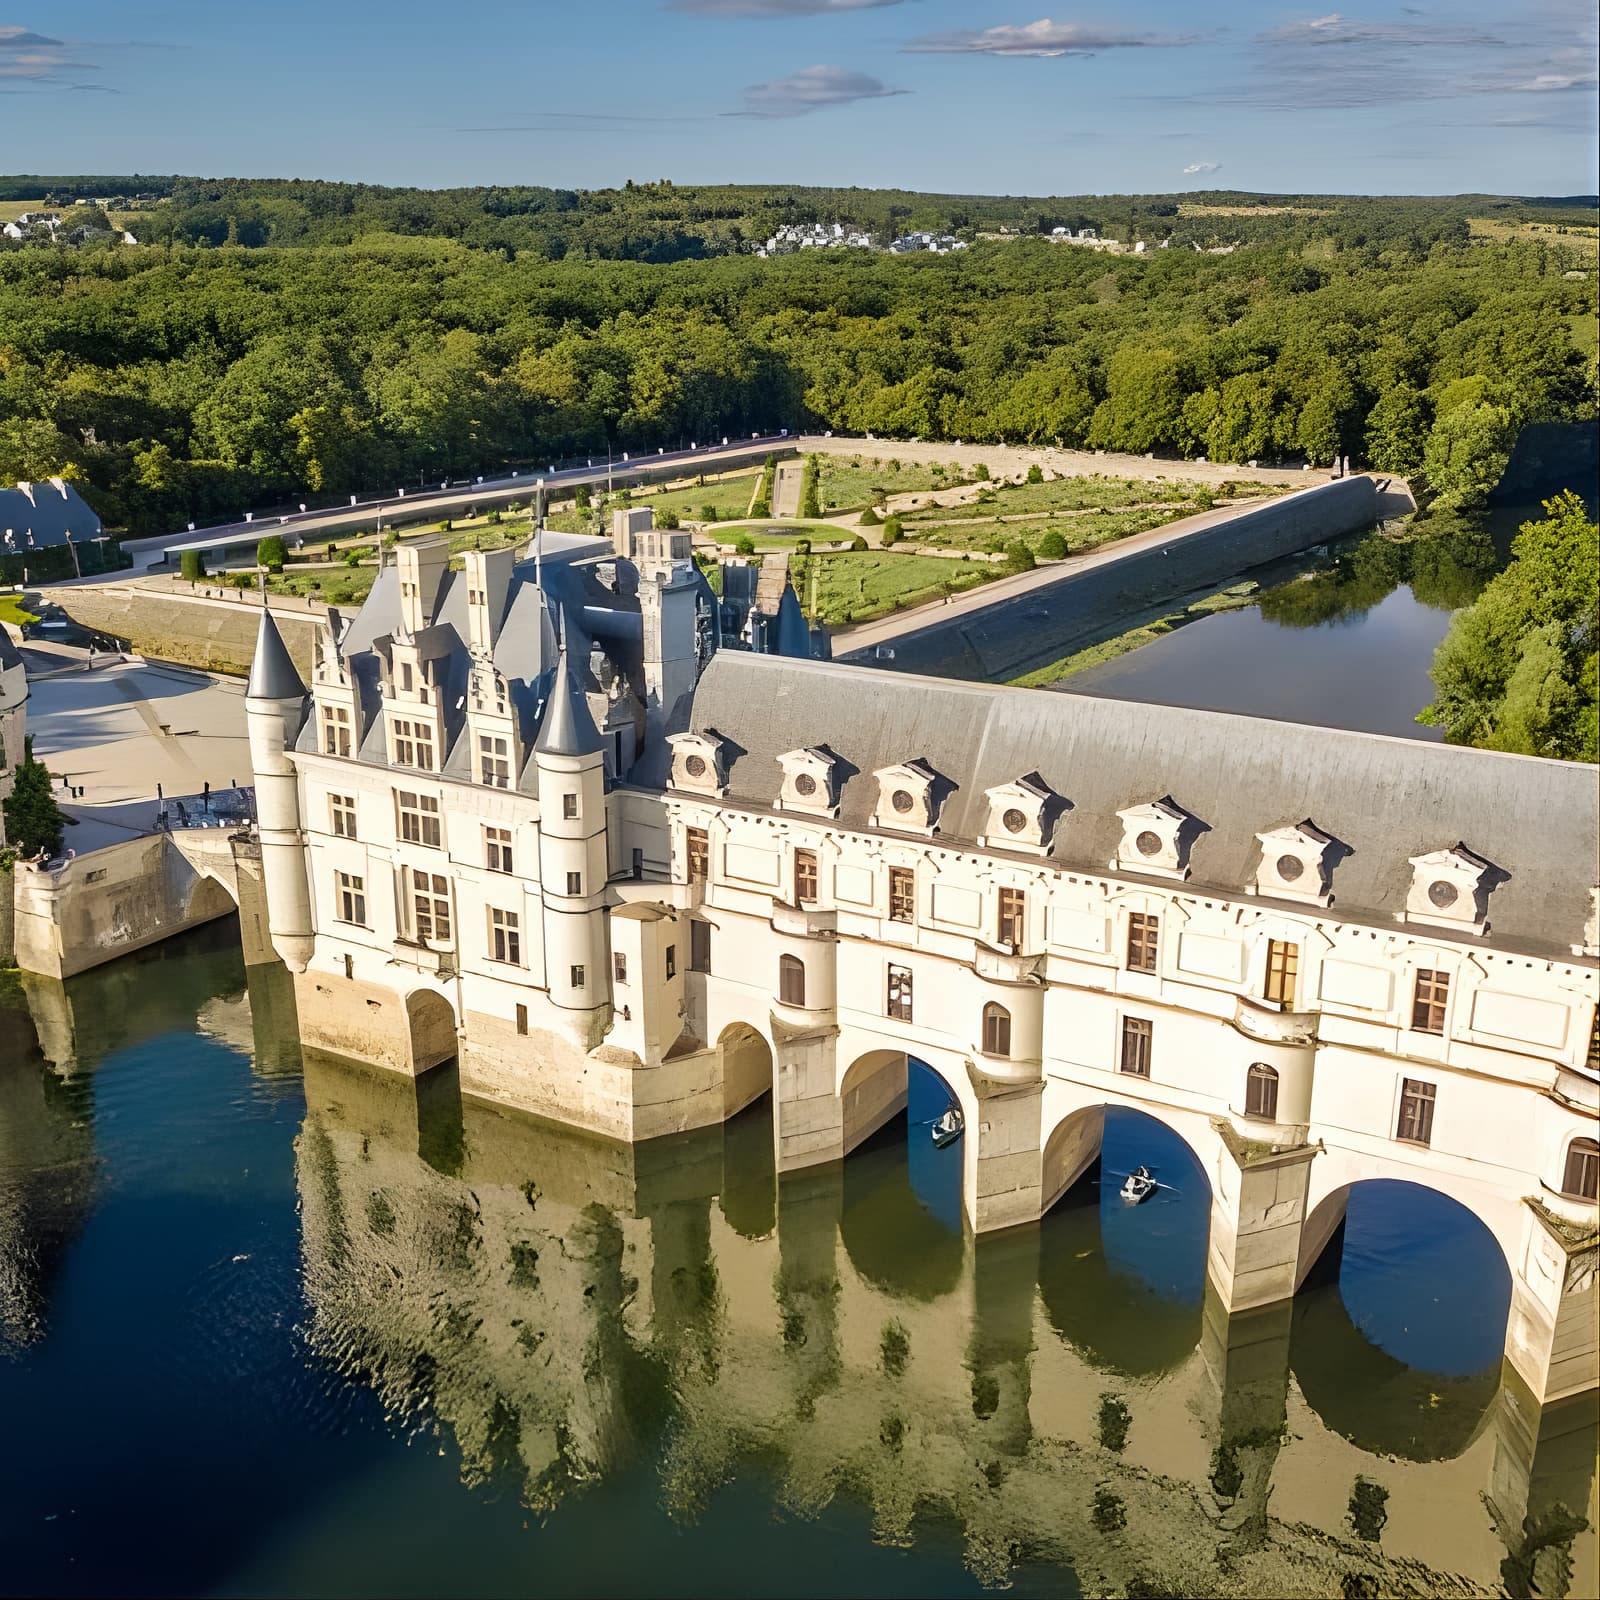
top-left (245, 611), bottom-right (314, 973)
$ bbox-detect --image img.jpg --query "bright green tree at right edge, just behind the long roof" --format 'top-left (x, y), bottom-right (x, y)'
top-left (1418, 491), bottom-right (1600, 762)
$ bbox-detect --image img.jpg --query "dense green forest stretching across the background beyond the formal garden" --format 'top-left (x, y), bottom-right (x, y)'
top-left (0, 178), bottom-right (1597, 531)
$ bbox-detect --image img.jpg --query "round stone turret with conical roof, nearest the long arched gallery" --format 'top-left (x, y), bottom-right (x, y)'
top-left (533, 640), bottom-right (610, 1048)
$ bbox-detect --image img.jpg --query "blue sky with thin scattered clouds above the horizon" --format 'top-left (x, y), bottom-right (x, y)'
top-left (0, 0), bottom-right (1597, 194)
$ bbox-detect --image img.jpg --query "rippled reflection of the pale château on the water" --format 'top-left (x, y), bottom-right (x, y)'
top-left (298, 1059), bottom-right (1595, 1595)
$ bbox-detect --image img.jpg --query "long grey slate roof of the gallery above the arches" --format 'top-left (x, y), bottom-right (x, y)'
top-left (675, 651), bottom-right (1600, 958)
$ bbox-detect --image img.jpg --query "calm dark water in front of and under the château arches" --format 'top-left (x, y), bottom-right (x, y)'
top-left (0, 934), bottom-right (1597, 1595)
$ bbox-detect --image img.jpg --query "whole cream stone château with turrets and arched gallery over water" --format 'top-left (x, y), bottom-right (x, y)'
top-left (248, 512), bottom-right (1600, 1402)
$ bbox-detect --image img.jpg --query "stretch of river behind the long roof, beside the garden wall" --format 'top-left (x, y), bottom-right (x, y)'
top-left (1051, 504), bottom-right (1542, 739)
